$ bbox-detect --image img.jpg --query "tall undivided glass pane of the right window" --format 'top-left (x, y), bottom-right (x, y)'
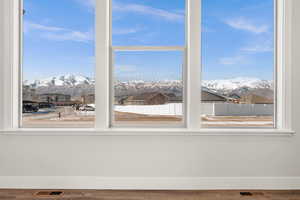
top-left (202, 0), bottom-right (275, 127)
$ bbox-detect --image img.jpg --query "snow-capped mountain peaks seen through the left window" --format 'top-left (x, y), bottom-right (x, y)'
top-left (24, 74), bottom-right (95, 88)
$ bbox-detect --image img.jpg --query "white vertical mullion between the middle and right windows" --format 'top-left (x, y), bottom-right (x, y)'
top-left (186, 0), bottom-right (201, 129)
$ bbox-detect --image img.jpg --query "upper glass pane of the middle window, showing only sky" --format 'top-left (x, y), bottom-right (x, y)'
top-left (112, 0), bottom-right (185, 46)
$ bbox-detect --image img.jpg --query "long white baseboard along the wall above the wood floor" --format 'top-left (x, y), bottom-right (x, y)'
top-left (0, 176), bottom-right (300, 190)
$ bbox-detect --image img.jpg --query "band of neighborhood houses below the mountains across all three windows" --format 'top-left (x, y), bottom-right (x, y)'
top-left (23, 83), bottom-right (273, 112)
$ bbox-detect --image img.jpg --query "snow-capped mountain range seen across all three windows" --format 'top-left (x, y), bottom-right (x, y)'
top-left (23, 74), bottom-right (273, 98)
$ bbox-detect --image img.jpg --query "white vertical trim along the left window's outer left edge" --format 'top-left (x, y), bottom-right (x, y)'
top-left (1, 0), bottom-right (20, 129)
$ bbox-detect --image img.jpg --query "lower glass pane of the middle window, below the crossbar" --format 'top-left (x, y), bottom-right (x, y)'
top-left (113, 51), bottom-right (184, 126)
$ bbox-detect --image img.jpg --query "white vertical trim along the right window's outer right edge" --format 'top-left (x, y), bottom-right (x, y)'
top-left (275, 0), bottom-right (292, 129)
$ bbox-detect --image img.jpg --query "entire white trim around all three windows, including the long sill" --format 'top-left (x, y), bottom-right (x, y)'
top-left (0, 0), bottom-right (294, 135)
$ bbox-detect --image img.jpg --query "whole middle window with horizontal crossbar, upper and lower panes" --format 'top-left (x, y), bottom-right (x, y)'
top-left (111, 0), bottom-right (186, 127)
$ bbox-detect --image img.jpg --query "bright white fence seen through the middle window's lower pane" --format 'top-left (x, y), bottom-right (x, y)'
top-left (114, 103), bottom-right (182, 116)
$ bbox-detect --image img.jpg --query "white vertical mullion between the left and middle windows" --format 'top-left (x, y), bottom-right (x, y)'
top-left (95, 0), bottom-right (110, 129)
